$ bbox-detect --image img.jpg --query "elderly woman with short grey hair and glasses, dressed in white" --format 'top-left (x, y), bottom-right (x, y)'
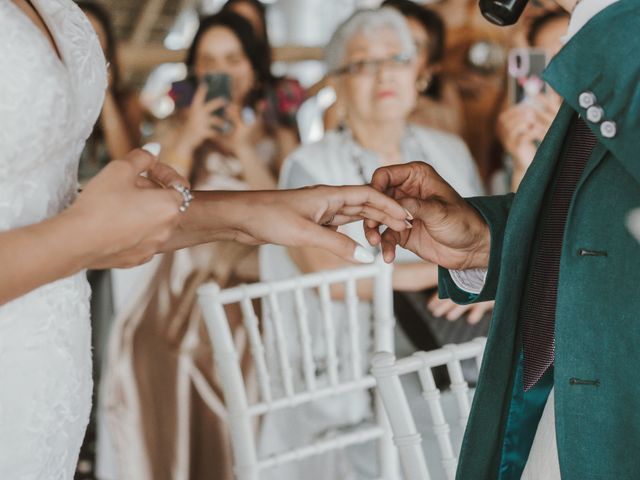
top-left (260, 8), bottom-right (483, 480)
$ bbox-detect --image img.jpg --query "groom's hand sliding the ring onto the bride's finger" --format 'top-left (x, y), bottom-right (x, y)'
top-left (365, 162), bottom-right (490, 270)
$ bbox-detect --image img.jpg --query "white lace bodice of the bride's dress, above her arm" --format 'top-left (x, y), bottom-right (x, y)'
top-left (0, 0), bottom-right (107, 231)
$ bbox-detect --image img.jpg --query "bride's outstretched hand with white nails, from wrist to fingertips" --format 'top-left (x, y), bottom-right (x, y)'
top-left (232, 185), bottom-right (410, 263)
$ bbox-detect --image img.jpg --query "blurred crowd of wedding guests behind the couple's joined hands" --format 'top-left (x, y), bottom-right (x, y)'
top-left (79, 0), bottom-right (568, 480)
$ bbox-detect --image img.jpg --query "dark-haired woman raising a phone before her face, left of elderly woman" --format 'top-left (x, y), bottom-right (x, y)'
top-left (159, 11), bottom-right (295, 184)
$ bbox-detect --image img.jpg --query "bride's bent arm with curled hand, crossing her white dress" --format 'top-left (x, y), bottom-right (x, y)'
top-left (0, 150), bottom-right (182, 305)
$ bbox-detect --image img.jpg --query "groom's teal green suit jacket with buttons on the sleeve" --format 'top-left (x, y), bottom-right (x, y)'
top-left (440, 0), bottom-right (640, 480)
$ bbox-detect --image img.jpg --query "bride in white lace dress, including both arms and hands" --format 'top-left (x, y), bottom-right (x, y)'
top-left (0, 0), bottom-right (406, 480)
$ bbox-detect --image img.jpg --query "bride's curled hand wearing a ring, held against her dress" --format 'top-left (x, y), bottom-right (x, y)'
top-left (66, 150), bottom-right (187, 268)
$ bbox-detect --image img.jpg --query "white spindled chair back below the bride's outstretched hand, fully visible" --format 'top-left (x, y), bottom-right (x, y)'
top-left (198, 261), bottom-right (399, 480)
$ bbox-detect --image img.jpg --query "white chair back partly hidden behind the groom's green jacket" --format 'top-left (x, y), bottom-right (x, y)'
top-left (371, 338), bottom-right (486, 480)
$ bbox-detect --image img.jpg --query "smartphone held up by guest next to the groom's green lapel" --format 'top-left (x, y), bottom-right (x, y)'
top-left (508, 48), bottom-right (547, 104)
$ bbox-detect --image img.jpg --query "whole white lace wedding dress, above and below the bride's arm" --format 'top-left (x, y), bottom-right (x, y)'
top-left (0, 0), bottom-right (107, 480)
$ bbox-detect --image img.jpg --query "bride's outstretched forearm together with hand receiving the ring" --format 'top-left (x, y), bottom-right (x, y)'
top-left (162, 186), bottom-right (407, 261)
